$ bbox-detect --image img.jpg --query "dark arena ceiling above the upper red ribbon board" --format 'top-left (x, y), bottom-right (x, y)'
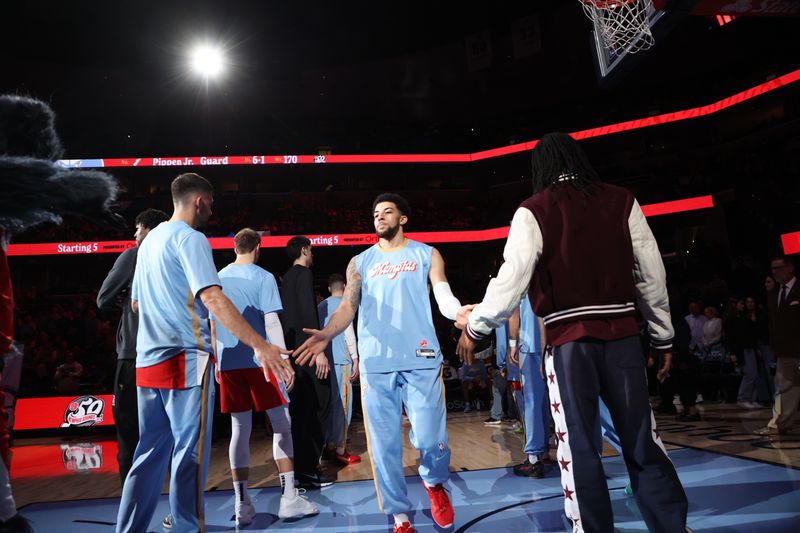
top-left (0, 0), bottom-right (800, 158)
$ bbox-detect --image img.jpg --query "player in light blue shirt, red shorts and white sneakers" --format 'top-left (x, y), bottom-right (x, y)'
top-left (211, 228), bottom-right (319, 526)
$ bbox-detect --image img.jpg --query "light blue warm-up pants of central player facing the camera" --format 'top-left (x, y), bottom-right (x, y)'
top-left (361, 367), bottom-right (450, 514)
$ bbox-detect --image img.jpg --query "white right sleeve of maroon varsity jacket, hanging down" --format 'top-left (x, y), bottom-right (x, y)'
top-left (628, 200), bottom-right (675, 350)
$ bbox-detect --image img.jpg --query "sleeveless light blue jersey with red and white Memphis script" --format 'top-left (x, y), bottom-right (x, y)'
top-left (356, 240), bottom-right (442, 373)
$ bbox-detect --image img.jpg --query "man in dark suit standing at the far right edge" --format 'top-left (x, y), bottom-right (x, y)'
top-left (757, 256), bottom-right (800, 435)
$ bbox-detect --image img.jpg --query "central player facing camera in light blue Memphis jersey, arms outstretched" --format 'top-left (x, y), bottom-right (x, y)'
top-left (295, 193), bottom-right (466, 533)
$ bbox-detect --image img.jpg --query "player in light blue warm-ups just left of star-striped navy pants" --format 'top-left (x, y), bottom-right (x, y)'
top-left (508, 295), bottom-right (550, 479)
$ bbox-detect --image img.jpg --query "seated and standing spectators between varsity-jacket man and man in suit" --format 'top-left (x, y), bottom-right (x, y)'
top-left (651, 266), bottom-right (776, 421)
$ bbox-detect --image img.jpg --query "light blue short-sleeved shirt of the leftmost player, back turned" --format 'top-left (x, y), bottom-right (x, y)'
top-left (131, 221), bottom-right (221, 372)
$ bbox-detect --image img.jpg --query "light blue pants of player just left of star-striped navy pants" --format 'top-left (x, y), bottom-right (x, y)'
top-left (519, 352), bottom-right (550, 456)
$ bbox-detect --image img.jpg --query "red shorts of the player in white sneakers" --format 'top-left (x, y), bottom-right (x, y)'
top-left (219, 368), bottom-right (288, 413)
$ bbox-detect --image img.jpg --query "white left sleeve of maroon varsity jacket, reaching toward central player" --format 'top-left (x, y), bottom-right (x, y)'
top-left (467, 207), bottom-right (542, 338)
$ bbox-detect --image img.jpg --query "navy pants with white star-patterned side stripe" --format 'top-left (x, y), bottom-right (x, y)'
top-left (545, 337), bottom-right (688, 533)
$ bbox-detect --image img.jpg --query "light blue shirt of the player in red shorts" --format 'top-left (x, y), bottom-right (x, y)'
top-left (216, 264), bottom-right (283, 370)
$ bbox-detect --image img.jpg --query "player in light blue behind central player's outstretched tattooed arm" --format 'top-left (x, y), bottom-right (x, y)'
top-left (317, 274), bottom-right (361, 466)
